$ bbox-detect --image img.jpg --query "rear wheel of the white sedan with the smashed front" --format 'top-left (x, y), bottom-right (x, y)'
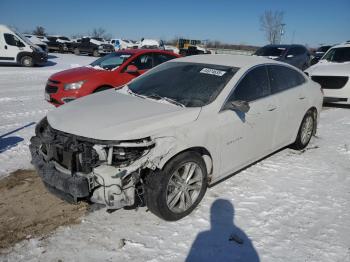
top-left (290, 110), bottom-right (316, 150)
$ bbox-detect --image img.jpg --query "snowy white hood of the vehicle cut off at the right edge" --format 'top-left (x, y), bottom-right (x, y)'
top-left (305, 60), bottom-right (350, 76)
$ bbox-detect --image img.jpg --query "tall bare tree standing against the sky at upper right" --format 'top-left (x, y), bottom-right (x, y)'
top-left (260, 10), bottom-right (284, 44)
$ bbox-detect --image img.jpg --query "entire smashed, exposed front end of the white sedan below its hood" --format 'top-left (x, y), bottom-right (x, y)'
top-left (30, 118), bottom-right (169, 209)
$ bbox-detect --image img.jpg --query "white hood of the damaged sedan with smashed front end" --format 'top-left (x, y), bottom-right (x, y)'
top-left (47, 89), bottom-right (200, 140)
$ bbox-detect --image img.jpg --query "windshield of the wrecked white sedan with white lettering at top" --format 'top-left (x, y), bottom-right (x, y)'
top-left (128, 62), bottom-right (239, 107)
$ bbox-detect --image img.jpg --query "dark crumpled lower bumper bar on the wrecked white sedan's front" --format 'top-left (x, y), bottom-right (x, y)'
top-left (29, 139), bottom-right (90, 203)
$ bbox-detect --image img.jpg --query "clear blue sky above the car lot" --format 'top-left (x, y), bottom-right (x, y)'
top-left (0, 0), bottom-right (350, 46)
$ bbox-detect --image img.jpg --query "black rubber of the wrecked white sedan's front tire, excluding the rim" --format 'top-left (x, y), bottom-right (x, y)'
top-left (144, 151), bottom-right (208, 221)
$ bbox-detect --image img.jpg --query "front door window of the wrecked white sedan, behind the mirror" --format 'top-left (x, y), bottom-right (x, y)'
top-left (228, 66), bottom-right (270, 102)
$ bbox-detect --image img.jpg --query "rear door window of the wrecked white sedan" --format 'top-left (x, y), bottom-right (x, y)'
top-left (267, 65), bottom-right (306, 94)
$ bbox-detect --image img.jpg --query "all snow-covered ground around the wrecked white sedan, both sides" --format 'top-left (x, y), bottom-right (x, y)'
top-left (0, 55), bottom-right (350, 262)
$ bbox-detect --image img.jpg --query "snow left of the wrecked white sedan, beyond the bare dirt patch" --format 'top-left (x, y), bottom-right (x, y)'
top-left (0, 54), bottom-right (96, 177)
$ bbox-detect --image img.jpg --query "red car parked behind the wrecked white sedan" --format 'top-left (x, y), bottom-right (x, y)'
top-left (45, 49), bottom-right (180, 106)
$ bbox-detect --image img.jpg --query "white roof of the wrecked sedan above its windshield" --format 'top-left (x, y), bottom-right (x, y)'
top-left (176, 54), bottom-right (281, 68)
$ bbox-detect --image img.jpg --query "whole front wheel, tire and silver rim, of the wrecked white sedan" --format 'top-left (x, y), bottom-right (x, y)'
top-left (145, 152), bottom-right (208, 221)
